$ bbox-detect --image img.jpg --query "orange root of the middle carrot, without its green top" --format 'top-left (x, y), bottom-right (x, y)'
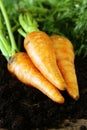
top-left (24, 31), bottom-right (66, 90)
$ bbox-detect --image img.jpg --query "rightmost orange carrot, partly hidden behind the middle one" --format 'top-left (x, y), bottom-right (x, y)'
top-left (51, 36), bottom-right (79, 99)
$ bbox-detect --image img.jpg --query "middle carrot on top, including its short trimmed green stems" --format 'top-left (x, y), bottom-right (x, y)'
top-left (19, 12), bottom-right (66, 90)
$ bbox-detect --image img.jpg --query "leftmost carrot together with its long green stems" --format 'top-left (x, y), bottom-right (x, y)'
top-left (0, 0), bottom-right (64, 103)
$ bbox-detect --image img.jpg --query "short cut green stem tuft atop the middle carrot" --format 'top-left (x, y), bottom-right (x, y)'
top-left (18, 12), bottom-right (39, 37)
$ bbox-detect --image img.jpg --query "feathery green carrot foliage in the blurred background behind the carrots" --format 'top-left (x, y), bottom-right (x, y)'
top-left (3, 0), bottom-right (87, 56)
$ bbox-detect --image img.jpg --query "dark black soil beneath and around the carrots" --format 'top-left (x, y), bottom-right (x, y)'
top-left (0, 54), bottom-right (87, 130)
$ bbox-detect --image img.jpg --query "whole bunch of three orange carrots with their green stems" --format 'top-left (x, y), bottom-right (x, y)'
top-left (0, 0), bottom-right (79, 103)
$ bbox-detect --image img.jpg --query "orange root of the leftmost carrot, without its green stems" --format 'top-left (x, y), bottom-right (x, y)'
top-left (7, 52), bottom-right (64, 104)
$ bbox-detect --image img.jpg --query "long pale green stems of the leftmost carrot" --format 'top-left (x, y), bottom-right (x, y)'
top-left (0, 0), bottom-right (19, 61)
